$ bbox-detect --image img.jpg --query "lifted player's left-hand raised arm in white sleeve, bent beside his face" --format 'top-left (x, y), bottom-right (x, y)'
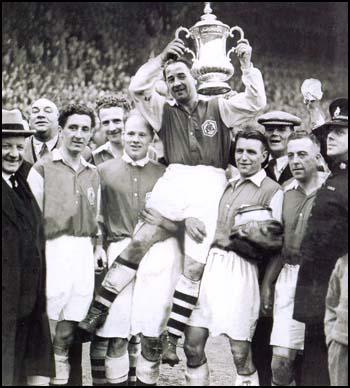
top-left (129, 39), bottom-right (185, 131)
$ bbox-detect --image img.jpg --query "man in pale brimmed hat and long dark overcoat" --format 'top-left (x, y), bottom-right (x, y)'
top-left (2, 109), bottom-right (54, 386)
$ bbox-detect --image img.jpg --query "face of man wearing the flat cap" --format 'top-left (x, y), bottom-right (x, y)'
top-left (265, 124), bottom-right (293, 158)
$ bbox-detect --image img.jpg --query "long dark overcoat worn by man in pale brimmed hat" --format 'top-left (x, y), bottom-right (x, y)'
top-left (2, 162), bottom-right (54, 385)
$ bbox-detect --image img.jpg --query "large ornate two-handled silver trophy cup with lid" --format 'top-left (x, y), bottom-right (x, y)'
top-left (175, 2), bottom-right (247, 95)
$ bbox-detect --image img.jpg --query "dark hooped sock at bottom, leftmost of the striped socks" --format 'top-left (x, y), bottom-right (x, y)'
top-left (90, 336), bottom-right (108, 385)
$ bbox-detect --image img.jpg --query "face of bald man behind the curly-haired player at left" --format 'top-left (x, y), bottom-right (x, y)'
top-left (29, 98), bottom-right (59, 136)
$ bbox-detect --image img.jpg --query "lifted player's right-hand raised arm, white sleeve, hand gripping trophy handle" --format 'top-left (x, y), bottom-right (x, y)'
top-left (219, 43), bottom-right (266, 127)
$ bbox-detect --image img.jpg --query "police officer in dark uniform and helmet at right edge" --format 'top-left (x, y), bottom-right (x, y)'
top-left (294, 98), bottom-right (348, 385)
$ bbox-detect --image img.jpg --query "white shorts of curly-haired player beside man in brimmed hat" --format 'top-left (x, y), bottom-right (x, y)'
top-left (46, 236), bottom-right (95, 322)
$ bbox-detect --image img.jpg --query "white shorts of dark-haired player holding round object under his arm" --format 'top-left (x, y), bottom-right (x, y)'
top-left (188, 248), bottom-right (260, 342)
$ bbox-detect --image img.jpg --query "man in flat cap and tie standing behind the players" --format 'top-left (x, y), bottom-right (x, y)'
top-left (258, 111), bottom-right (301, 185)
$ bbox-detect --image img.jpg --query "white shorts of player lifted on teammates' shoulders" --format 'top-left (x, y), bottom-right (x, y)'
top-left (146, 164), bottom-right (227, 264)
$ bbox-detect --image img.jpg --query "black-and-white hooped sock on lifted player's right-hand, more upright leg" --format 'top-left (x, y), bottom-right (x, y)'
top-left (168, 275), bottom-right (201, 337)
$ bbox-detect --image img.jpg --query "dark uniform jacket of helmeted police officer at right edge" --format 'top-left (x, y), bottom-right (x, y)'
top-left (294, 162), bottom-right (348, 323)
